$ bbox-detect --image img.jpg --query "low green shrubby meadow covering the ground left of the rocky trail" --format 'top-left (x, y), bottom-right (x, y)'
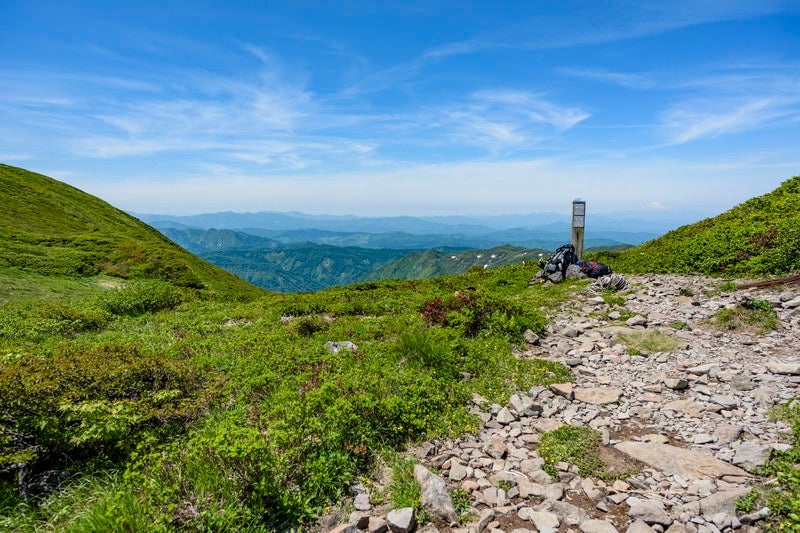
top-left (0, 266), bottom-right (580, 531)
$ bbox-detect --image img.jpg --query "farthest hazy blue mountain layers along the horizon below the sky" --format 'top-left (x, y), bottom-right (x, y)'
top-left (137, 208), bottom-right (700, 250)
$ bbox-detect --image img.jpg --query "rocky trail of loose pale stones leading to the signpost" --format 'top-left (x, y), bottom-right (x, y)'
top-left (320, 275), bottom-right (800, 533)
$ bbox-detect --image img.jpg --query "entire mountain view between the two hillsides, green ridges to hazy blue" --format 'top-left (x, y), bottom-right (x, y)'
top-left (138, 208), bottom-right (699, 292)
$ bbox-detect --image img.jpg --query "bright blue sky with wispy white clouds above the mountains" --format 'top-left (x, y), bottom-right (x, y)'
top-left (0, 0), bottom-right (800, 215)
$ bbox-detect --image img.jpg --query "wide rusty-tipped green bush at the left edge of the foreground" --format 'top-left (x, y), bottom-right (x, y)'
top-left (0, 344), bottom-right (218, 468)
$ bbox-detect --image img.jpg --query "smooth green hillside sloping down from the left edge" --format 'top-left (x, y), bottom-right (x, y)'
top-left (0, 165), bottom-right (259, 303)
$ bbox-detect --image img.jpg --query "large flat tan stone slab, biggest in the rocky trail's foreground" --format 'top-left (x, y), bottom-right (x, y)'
top-left (614, 441), bottom-right (748, 479)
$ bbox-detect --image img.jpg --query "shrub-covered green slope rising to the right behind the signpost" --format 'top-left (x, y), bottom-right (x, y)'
top-left (593, 176), bottom-right (800, 276)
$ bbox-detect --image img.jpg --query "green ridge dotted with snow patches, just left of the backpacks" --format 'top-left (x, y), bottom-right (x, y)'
top-left (364, 246), bottom-right (548, 281)
